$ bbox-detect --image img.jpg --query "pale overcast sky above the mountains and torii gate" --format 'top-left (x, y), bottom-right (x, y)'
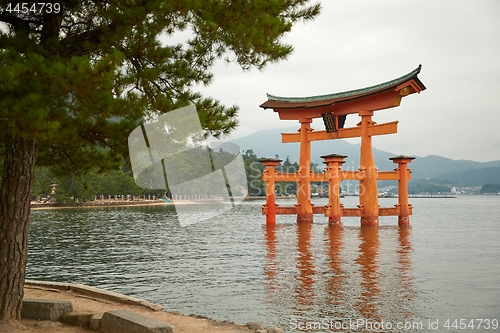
top-left (200, 0), bottom-right (500, 162)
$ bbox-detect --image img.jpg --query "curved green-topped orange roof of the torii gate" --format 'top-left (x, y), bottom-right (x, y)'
top-left (260, 65), bottom-right (426, 119)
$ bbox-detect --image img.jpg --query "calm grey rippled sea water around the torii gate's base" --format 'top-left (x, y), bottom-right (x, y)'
top-left (27, 196), bottom-right (500, 332)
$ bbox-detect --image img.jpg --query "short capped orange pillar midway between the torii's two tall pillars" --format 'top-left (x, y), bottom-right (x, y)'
top-left (321, 154), bottom-right (347, 225)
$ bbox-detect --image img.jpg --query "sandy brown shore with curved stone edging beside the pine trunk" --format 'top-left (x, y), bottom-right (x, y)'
top-left (9, 280), bottom-right (284, 333)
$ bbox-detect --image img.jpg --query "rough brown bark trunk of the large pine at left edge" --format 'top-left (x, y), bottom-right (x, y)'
top-left (0, 134), bottom-right (36, 321)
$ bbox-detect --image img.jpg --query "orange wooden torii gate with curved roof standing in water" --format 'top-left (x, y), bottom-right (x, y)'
top-left (260, 65), bottom-right (425, 225)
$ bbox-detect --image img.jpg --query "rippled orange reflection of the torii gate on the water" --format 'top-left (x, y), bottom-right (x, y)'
top-left (263, 223), bottom-right (415, 324)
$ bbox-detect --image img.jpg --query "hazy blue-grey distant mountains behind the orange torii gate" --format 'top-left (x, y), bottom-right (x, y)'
top-left (231, 126), bottom-right (500, 186)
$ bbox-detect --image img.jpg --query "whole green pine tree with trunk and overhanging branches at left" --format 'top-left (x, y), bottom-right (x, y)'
top-left (0, 0), bottom-right (320, 321)
